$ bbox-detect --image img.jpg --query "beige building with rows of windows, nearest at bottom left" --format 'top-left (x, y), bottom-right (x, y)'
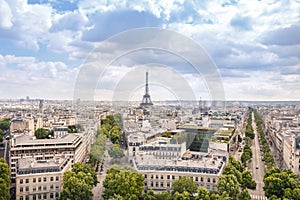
top-left (16, 156), bottom-right (72, 200)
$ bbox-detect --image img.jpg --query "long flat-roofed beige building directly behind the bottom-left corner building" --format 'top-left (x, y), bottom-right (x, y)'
top-left (10, 134), bottom-right (85, 183)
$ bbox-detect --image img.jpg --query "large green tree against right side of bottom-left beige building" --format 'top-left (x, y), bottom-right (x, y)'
top-left (60, 163), bottom-right (98, 200)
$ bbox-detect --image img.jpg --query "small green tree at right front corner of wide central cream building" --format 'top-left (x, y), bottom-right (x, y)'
top-left (217, 174), bottom-right (240, 199)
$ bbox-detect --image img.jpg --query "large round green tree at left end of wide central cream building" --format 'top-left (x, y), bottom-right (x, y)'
top-left (103, 165), bottom-right (144, 200)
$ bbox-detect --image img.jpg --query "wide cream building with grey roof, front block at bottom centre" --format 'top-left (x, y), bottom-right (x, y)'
top-left (133, 152), bottom-right (227, 191)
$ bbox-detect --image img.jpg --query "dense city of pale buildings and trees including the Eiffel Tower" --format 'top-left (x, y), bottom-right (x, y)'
top-left (0, 80), bottom-right (300, 200)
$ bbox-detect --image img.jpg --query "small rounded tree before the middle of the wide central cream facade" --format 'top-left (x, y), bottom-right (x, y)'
top-left (172, 176), bottom-right (198, 195)
